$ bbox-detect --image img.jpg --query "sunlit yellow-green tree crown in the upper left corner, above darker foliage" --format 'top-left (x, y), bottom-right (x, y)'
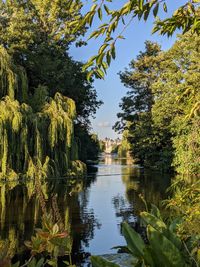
top-left (0, 0), bottom-right (83, 53)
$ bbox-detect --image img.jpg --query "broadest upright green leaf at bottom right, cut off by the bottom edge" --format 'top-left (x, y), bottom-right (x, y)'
top-left (147, 225), bottom-right (185, 267)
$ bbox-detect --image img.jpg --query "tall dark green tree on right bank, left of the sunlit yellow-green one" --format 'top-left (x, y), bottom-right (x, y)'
top-left (114, 41), bottom-right (172, 172)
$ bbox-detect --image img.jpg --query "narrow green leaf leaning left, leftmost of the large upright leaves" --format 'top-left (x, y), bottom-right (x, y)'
top-left (122, 222), bottom-right (145, 257)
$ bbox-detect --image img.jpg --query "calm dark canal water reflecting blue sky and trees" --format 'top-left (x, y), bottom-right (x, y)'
top-left (0, 155), bottom-right (170, 267)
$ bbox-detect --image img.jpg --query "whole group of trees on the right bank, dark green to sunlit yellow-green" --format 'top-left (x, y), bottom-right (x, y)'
top-left (114, 33), bottom-right (200, 175)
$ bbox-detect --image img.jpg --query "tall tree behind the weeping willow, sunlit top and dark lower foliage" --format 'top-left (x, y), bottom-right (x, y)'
top-left (0, 0), bottom-right (101, 126)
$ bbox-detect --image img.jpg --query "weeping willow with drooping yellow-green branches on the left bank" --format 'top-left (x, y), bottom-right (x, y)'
top-left (0, 47), bottom-right (85, 179)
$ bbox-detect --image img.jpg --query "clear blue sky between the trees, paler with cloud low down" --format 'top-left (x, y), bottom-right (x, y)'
top-left (70, 0), bottom-right (185, 139)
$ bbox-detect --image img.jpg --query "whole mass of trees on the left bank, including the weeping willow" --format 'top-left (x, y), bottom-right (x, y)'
top-left (0, 0), bottom-right (102, 180)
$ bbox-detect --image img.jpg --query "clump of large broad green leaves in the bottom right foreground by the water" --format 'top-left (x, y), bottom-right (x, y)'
top-left (91, 206), bottom-right (200, 267)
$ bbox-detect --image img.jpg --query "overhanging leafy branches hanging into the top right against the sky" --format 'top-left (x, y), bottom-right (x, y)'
top-left (76, 0), bottom-right (200, 79)
